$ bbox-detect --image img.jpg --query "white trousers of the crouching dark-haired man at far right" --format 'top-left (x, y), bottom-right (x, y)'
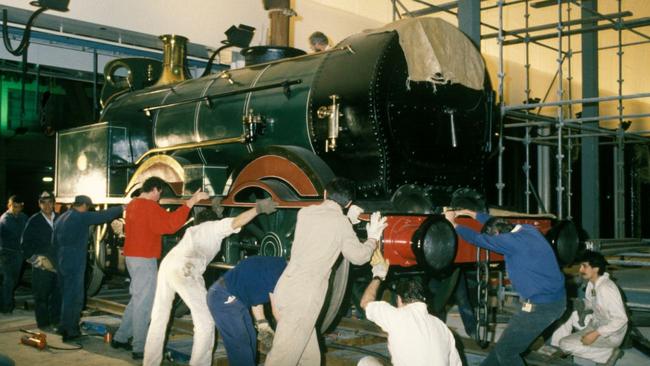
top-left (551, 311), bottom-right (620, 363)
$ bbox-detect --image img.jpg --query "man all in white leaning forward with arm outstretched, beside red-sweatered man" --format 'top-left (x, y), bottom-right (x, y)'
top-left (143, 199), bottom-right (277, 365)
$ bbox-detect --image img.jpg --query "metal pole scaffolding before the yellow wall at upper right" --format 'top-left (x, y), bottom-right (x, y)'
top-left (391, 0), bottom-right (650, 238)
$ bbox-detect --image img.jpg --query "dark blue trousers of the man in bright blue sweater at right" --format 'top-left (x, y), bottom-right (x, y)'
top-left (481, 299), bottom-right (566, 366)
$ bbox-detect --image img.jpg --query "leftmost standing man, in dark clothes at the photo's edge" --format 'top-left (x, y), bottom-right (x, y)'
top-left (0, 195), bottom-right (27, 313)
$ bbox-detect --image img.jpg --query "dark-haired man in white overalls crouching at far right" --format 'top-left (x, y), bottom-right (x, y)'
top-left (551, 251), bottom-right (627, 363)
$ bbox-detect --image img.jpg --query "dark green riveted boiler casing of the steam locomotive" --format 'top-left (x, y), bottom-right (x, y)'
top-left (95, 32), bottom-right (491, 204)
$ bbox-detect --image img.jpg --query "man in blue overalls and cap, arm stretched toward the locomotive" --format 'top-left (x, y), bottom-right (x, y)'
top-left (53, 196), bottom-right (123, 342)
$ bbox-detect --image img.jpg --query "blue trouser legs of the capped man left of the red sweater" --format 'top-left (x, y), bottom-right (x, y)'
top-left (57, 246), bottom-right (87, 336)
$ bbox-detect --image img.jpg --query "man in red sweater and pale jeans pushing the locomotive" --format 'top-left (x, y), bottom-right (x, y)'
top-left (111, 177), bottom-right (209, 360)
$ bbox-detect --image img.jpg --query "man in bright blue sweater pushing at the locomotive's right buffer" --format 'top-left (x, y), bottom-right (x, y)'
top-left (445, 210), bottom-right (566, 366)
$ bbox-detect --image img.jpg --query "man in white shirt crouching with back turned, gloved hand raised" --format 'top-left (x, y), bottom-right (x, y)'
top-left (357, 252), bottom-right (462, 366)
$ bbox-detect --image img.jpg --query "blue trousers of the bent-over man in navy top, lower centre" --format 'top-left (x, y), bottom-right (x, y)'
top-left (208, 282), bottom-right (257, 366)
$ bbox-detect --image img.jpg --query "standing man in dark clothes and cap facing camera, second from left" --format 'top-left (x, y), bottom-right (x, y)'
top-left (21, 191), bottom-right (61, 329)
